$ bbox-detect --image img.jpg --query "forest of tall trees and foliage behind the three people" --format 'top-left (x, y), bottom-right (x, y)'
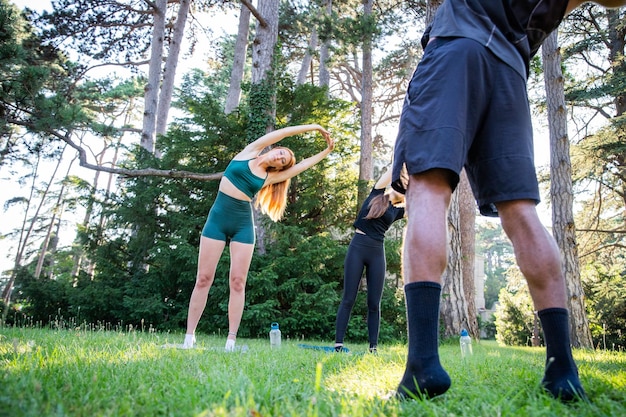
top-left (0, 0), bottom-right (626, 349)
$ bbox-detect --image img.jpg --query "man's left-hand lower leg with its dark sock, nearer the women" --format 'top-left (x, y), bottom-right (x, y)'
top-left (397, 169), bottom-right (452, 398)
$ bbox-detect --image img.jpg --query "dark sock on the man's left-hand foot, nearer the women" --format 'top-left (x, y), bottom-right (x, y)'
top-left (396, 282), bottom-right (451, 399)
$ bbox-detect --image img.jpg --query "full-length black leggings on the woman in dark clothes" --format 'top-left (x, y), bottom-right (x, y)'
top-left (335, 233), bottom-right (387, 347)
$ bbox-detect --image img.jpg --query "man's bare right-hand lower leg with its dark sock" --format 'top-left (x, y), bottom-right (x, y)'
top-left (497, 200), bottom-right (585, 401)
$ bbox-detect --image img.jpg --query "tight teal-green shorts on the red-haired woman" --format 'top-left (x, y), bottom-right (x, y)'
top-left (202, 191), bottom-right (256, 245)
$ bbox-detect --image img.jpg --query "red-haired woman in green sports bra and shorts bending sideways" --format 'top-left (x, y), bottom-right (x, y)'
top-left (182, 124), bottom-right (334, 351)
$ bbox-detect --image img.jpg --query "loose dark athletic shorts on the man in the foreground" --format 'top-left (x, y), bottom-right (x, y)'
top-left (392, 38), bottom-right (540, 216)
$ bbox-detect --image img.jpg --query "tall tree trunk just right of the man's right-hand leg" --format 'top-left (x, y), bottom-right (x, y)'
top-left (541, 30), bottom-right (593, 348)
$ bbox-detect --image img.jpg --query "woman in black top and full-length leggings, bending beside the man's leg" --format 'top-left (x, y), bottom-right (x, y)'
top-left (335, 169), bottom-right (404, 353)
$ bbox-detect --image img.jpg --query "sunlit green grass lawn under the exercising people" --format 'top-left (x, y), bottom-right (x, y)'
top-left (0, 328), bottom-right (626, 417)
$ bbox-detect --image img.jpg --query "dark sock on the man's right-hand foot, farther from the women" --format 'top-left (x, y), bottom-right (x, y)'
top-left (537, 308), bottom-right (587, 402)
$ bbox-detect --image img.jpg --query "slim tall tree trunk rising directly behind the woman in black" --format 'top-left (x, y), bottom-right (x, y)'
top-left (357, 0), bottom-right (374, 207)
